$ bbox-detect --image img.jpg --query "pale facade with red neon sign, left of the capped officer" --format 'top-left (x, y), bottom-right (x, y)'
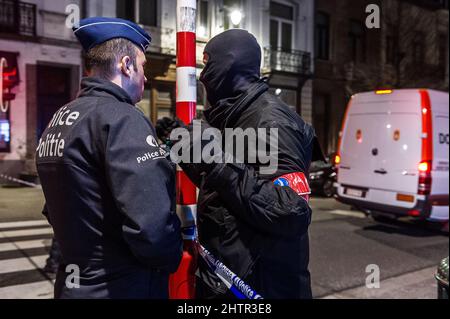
top-left (0, 0), bottom-right (82, 177)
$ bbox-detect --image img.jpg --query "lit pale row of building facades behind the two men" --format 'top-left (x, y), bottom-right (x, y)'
top-left (0, 0), bottom-right (314, 182)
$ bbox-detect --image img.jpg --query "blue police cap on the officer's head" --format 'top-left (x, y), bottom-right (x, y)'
top-left (73, 17), bottom-right (152, 52)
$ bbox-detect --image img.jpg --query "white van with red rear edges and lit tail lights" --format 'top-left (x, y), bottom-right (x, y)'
top-left (335, 89), bottom-right (449, 225)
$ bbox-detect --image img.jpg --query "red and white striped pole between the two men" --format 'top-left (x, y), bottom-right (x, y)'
top-left (169, 0), bottom-right (197, 299)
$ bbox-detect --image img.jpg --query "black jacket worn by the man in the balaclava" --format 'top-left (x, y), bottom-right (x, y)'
top-left (188, 81), bottom-right (321, 298)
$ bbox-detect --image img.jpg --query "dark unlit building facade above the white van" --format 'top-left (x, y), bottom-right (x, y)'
top-left (313, 0), bottom-right (449, 154)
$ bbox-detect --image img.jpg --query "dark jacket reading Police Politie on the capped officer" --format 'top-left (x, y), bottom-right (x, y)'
top-left (36, 78), bottom-right (182, 299)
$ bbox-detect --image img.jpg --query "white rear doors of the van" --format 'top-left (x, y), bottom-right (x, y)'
top-left (338, 100), bottom-right (422, 198)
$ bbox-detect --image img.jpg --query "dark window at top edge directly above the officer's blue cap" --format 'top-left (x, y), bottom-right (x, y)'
top-left (116, 0), bottom-right (158, 27)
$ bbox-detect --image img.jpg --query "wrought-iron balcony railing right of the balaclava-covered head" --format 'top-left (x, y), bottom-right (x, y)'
top-left (263, 47), bottom-right (311, 75)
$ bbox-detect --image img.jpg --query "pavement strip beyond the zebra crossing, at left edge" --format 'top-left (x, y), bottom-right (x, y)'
top-left (0, 187), bottom-right (45, 222)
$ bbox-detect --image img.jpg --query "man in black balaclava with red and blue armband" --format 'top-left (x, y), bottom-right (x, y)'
top-left (160, 29), bottom-right (321, 298)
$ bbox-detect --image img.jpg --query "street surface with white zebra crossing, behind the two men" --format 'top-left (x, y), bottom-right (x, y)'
top-left (0, 188), bottom-right (449, 299)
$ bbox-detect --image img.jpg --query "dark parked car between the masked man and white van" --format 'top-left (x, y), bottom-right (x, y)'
top-left (309, 155), bottom-right (336, 197)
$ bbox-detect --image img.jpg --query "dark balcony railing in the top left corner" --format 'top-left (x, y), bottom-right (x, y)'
top-left (0, 0), bottom-right (36, 36)
